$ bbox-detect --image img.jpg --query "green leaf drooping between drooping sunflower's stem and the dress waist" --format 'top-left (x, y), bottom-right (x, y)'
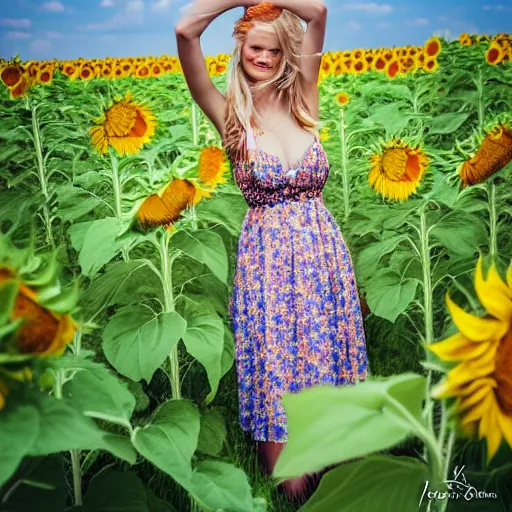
top-left (171, 230), bottom-right (228, 284)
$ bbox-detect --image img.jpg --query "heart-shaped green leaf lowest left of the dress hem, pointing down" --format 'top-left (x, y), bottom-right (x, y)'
top-left (132, 400), bottom-right (200, 487)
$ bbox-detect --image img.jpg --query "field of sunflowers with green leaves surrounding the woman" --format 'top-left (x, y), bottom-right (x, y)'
top-left (0, 33), bottom-right (512, 512)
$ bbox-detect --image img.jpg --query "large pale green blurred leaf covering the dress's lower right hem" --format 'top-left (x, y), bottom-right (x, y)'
top-left (274, 373), bottom-right (425, 477)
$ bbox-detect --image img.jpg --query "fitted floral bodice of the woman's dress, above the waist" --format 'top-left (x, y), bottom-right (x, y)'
top-left (231, 126), bottom-right (329, 208)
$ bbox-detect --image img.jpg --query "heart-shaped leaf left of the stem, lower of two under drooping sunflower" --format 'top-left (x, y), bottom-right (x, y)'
top-left (103, 306), bottom-right (187, 382)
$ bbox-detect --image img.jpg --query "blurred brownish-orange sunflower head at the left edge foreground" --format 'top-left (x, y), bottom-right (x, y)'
top-left (0, 266), bottom-right (77, 356)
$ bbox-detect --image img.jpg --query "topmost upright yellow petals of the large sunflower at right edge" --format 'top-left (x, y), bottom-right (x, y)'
top-left (475, 256), bottom-right (512, 322)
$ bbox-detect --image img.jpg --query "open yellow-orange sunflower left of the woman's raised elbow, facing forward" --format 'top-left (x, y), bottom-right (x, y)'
top-left (89, 92), bottom-right (156, 155)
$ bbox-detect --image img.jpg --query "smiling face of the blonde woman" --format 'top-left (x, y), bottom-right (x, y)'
top-left (242, 24), bottom-right (282, 82)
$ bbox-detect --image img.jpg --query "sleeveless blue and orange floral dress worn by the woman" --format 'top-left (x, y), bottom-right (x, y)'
top-left (229, 126), bottom-right (368, 442)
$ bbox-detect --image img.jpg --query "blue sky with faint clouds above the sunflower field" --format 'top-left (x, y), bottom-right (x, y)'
top-left (0, 0), bottom-right (512, 60)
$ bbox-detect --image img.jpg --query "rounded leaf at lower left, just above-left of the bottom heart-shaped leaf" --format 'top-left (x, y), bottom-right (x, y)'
top-left (64, 365), bottom-right (135, 428)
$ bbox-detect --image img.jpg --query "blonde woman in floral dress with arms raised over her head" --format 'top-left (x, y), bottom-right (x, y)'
top-left (175, 0), bottom-right (367, 504)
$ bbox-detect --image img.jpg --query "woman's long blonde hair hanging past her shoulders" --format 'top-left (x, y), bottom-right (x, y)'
top-left (223, 8), bottom-right (318, 161)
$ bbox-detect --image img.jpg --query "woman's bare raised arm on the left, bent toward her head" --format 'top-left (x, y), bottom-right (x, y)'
top-left (174, 0), bottom-right (257, 137)
